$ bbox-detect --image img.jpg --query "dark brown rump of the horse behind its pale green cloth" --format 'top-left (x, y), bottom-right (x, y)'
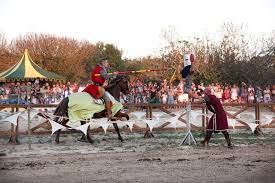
top-left (53, 97), bottom-right (69, 124)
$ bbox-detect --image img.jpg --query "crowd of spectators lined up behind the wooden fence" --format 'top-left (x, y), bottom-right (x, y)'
top-left (0, 79), bottom-right (275, 104)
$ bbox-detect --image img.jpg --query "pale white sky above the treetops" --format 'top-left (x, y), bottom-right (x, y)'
top-left (0, 0), bottom-right (275, 58)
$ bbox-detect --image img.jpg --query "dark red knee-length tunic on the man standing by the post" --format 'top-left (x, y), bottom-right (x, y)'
top-left (206, 95), bottom-right (228, 132)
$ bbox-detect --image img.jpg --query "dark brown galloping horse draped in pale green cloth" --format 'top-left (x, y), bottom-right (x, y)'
top-left (54, 77), bottom-right (129, 143)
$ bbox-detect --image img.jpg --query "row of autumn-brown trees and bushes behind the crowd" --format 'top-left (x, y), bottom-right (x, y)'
top-left (0, 22), bottom-right (275, 85)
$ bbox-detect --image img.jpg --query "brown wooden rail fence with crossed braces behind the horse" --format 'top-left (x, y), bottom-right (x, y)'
top-left (0, 102), bottom-right (275, 143)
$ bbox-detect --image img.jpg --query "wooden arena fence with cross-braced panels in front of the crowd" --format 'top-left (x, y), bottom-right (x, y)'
top-left (0, 103), bottom-right (275, 143)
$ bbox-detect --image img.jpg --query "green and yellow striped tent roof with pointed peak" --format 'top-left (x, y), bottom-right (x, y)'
top-left (0, 49), bottom-right (65, 81)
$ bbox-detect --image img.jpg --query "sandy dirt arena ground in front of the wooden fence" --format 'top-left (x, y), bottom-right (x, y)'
top-left (0, 130), bottom-right (275, 183)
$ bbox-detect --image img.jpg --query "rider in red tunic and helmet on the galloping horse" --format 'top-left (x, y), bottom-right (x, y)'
top-left (83, 58), bottom-right (117, 120)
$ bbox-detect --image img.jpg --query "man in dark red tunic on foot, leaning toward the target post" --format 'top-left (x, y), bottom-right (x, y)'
top-left (202, 87), bottom-right (232, 148)
